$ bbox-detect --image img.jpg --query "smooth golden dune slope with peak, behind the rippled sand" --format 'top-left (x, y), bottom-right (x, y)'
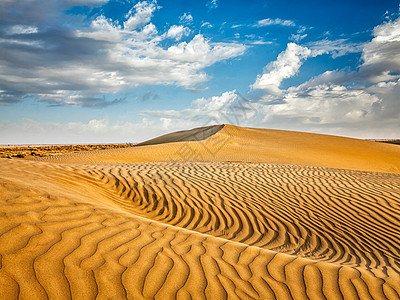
top-left (36, 125), bottom-right (400, 174)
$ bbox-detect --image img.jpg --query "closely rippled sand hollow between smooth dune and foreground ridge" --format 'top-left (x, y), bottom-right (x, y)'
top-left (74, 163), bottom-right (400, 274)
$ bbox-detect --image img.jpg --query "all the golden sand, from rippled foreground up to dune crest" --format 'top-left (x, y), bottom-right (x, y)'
top-left (0, 125), bottom-right (400, 299)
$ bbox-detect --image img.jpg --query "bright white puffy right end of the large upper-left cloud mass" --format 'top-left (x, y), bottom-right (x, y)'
top-left (81, 18), bottom-right (245, 86)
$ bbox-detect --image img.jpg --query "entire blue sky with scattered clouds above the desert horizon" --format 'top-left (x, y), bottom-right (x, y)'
top-left (0, 0), bottom-right (400, 144)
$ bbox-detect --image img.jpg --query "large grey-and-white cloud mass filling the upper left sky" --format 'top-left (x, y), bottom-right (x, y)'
top-left (0, 0), bottom-right (246, 107)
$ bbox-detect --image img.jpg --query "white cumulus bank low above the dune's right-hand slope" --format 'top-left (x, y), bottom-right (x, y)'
top-left (253, 74), bottom-right (400, 138)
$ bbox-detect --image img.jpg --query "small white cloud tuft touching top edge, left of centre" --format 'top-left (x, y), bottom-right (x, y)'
top-left (124, 0), bottom-right (159, 30)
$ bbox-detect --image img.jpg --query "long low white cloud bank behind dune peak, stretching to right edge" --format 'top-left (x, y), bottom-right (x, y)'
top-left (143, 80), bottom-right (400, 138)
